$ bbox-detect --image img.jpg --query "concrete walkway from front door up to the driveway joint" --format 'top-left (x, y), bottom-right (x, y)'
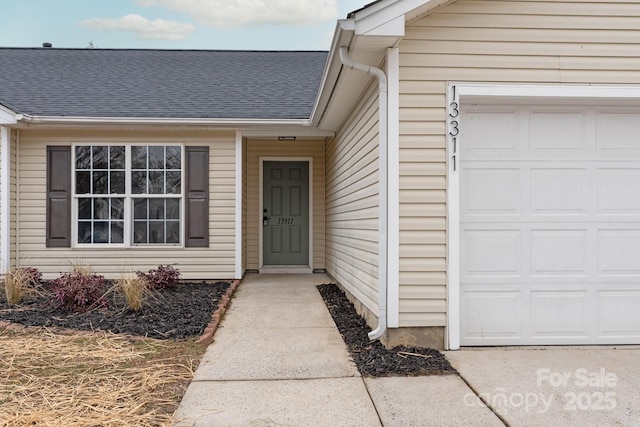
top-left (176, 274), bottom-right (503, 427)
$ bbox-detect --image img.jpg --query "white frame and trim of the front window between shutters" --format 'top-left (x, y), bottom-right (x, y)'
top-left (71, 145), bottom-right (186, 250)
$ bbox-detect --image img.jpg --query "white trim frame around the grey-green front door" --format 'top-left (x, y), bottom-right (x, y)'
top-left (257, 156), bottom-right (313, 274)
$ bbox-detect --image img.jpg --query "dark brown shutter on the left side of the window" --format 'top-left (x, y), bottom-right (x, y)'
top-left (47, 146), bottom-right (71, 248)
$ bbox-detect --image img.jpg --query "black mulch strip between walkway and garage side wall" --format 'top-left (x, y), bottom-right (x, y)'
top-left (318, 284), bottom-right (457, 377)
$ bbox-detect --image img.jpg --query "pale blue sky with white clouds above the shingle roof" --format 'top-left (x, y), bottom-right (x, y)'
top-left (0, 0), bottom-right (371, 50)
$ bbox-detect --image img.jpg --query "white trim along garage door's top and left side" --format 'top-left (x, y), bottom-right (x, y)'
top-left (446, 84), bottom-right (640, 350)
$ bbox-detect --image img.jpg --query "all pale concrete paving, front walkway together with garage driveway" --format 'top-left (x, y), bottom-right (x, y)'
top-left (176, 274), bottom-right (640, 427)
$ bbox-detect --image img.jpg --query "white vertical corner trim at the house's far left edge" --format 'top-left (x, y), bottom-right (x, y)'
top-left (0, 126), bottom-right (11, 274)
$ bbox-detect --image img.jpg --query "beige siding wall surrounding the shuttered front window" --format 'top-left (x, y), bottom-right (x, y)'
top-left (18, 131), bottom-right (235, 279)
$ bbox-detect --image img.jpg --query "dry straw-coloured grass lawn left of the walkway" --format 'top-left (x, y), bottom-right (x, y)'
top-left (0, 329), bottom-right (204, 427)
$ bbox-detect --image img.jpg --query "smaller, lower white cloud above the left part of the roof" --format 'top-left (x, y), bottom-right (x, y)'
top-left (80, 14), bottom-right (196, 40)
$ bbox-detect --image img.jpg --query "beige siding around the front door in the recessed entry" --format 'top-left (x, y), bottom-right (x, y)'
top-left (246, 139), bottom-right (325, 270)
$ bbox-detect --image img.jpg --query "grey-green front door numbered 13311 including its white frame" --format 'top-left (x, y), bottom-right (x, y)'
top-left (258, 157), bottom-right (314, 273)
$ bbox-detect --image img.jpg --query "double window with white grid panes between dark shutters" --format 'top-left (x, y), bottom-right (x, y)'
top-left (74, 145), bottom-right (184, 246)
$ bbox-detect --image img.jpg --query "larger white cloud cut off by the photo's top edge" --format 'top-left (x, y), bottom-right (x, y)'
top-left (136, 0), bottom-right (338, 28)
